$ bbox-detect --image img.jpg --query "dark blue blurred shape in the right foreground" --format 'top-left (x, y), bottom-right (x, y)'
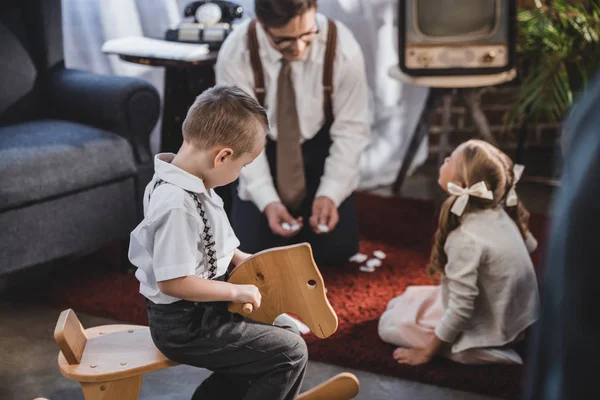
top-left (525, 70), bottom-right (600, 400)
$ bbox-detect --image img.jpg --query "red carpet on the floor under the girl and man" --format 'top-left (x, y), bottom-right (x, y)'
top-left (18, 194), bottom-right (547, 398)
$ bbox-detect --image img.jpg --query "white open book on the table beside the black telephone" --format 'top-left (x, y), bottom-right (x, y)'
top-left (102, 36), bottom-right (209, 61)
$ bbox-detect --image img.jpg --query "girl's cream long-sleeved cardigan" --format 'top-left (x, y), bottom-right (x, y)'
top-left (435, 208), bottom-right (539, 353)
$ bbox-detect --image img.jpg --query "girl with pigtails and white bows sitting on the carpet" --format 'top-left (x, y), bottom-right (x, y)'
top-left (379, 140), bottom-right (539, 365)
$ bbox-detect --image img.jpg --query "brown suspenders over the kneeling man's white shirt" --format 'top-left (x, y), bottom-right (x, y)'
top-left (248, 19), bottom-right (337, 124)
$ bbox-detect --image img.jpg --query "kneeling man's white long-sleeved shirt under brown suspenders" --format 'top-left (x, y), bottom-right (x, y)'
top-left (215, 14), bottom-right (371, 211)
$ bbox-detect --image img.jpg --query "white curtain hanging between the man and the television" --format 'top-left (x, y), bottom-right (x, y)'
top-left (319, 0), bottom-right (428, 189)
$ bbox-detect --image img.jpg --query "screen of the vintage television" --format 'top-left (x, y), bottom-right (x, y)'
top-left (415, 0), bottom-right (497, 38)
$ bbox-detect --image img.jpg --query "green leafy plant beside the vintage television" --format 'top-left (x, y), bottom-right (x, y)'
top-left (508, 0), bottom-right (600, 126)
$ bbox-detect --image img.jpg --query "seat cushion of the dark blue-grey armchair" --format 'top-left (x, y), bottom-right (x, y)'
top-left (0, 120), bottom-right (136, 210)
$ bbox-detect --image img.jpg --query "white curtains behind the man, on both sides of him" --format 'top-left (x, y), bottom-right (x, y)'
top-left (63, 0), bottom-right (427, 188)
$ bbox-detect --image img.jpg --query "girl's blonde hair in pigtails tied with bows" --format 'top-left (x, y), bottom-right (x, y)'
top-left (428, 140), bottom-right (529, 277)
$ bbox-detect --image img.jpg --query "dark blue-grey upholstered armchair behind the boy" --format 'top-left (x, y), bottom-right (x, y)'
top-left (0, 0), bottom-right (160, 275)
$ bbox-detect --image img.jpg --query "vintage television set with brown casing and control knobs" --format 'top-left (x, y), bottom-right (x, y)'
top-left (398, 0), bottom-right (516, 77)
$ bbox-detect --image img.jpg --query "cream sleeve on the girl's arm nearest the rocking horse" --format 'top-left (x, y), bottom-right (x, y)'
top-left (435, 231), bottom-right (483, 343)
